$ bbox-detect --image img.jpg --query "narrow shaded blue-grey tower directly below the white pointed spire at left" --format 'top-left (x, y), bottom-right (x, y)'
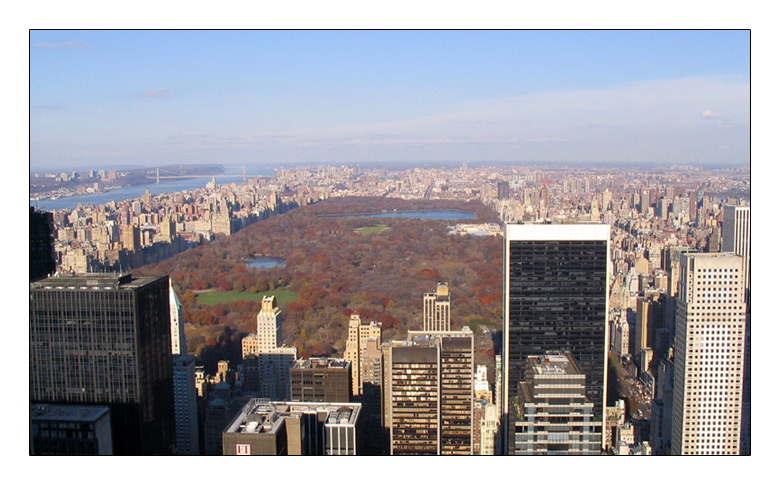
top-left (173, 354), bottom-right (200, 455)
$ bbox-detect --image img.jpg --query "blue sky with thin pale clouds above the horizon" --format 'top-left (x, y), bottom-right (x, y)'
top-left (29, 30), bottom-right (750, 170)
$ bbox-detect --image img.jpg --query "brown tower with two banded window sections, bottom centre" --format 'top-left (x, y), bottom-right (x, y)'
top-left (384, 329), bottom-right (474, 455)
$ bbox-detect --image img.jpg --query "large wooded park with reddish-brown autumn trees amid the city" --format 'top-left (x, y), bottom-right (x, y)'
top-left (134, 197), bottom-right (502, 372)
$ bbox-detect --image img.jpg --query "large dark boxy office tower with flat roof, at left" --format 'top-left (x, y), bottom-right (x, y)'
top-left (30, 274), bottom-right (174, 455)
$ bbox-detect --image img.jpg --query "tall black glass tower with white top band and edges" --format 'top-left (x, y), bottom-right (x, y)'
top-left (502, 224), bottom-right (609, 454)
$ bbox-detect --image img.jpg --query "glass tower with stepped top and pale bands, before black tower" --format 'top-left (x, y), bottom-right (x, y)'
top-left (509, 352), bottom-right (602, 455)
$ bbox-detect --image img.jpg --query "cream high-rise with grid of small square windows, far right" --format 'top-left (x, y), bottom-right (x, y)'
top-left (671, 253), bottom-right (745, 455)
